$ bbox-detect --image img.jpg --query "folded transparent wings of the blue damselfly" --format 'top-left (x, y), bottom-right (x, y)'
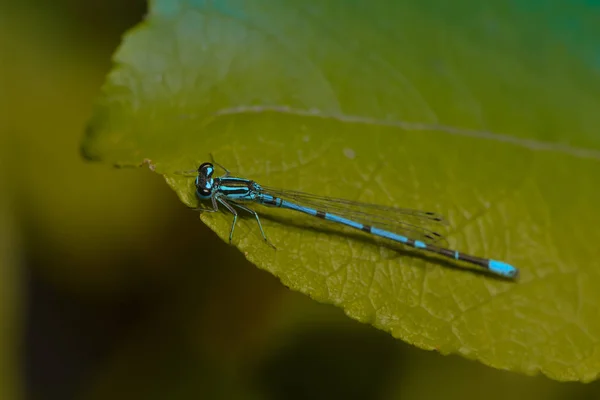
top-left (262, 186), bottom-right (447, 244)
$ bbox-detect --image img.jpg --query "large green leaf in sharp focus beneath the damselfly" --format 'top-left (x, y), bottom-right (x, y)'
top-left (83, 0), bottom-right (600, 381)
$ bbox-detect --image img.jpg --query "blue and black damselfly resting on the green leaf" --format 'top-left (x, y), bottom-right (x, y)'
top-left (188, 161), bottom-right (519, 278)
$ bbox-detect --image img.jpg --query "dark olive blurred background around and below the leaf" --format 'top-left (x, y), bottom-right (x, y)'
top-left (0, 0), bottom-right (600, 400)
